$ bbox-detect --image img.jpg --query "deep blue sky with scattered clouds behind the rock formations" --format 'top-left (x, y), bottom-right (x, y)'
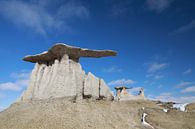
top-left (0, 0), bottom-right (195, 109)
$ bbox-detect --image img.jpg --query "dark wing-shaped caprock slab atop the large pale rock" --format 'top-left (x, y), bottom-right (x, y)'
top-left (23, 43), bottom-right (117, 63)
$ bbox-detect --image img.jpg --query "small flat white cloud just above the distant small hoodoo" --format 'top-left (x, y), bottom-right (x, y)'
top-left (108, 78), bottom-right (135, 86)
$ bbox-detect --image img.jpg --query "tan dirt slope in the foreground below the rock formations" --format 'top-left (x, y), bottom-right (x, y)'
top-left (0, 99), bottom-right (195, 129)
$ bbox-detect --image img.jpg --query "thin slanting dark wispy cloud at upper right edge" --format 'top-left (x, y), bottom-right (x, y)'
top-left (171, 20), bottom-right (195, 34)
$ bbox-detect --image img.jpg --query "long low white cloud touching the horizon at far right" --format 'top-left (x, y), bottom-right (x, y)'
top-left (148, 93), bottom-right (195, 103)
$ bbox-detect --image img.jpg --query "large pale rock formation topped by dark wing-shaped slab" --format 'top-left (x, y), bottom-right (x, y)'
top-left (19, 44), bottom-right (116, 101)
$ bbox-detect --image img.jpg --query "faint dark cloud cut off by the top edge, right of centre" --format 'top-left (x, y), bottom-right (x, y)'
top-left (146, 0), bottom-right (173, 12)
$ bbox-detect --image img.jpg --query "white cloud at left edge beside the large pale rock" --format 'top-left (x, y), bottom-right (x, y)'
top-left (0, 72), bottom-right (30, 91)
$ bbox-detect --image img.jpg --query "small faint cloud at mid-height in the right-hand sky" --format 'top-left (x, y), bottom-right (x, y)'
top-left (148, 62), bottom-right (169, 73)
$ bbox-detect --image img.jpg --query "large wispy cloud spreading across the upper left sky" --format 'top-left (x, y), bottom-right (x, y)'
top-left (0, 0), bottom-right (89, 36)
